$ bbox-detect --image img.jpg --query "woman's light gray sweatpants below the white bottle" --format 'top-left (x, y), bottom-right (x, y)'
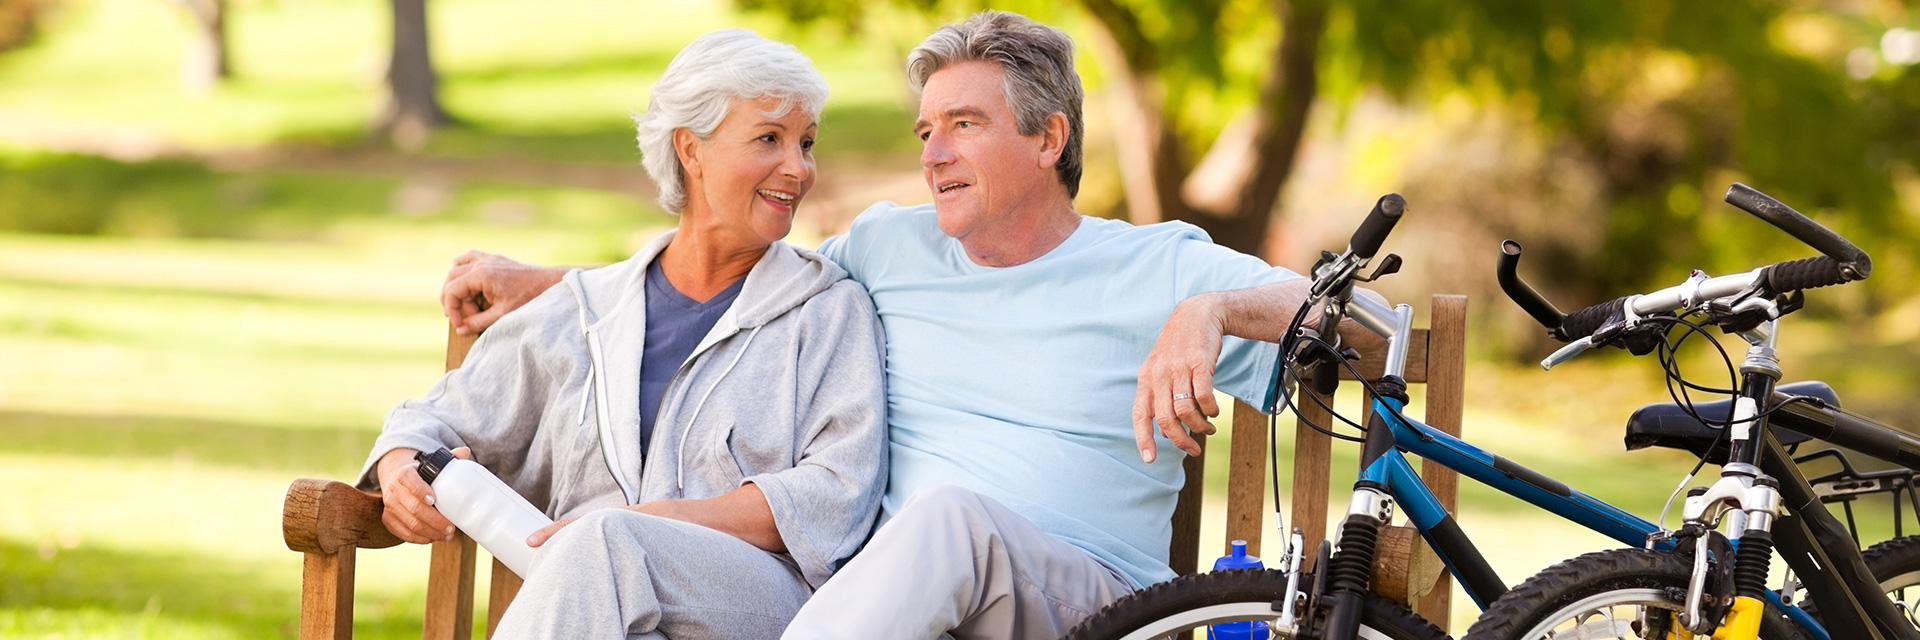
top-left (497, 509), bottom-right (808, 640)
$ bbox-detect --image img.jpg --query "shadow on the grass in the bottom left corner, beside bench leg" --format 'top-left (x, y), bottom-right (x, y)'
top-left (0, 540), bottom-right (420, 638)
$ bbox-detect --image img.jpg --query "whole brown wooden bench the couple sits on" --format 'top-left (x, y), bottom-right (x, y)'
top-left (280, 296), bottom-right (1467, 640)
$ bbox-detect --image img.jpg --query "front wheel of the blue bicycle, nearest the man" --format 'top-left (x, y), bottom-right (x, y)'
top-left (1066, 569), bottom-right (1448, 640)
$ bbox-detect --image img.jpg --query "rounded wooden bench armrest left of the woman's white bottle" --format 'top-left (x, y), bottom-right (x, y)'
top-left (280, 479), bottom-right (401, 554)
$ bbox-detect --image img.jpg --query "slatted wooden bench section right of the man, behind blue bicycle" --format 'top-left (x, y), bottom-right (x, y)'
top-left (1169, 294), bottom-right (1467, 628)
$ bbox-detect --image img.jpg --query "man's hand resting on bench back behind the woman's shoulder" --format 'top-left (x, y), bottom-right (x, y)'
top-left (440, 250), bottom-right (566, 334)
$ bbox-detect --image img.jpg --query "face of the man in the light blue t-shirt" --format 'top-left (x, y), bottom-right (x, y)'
top-left (914, 62), bottom-right (1058, 240)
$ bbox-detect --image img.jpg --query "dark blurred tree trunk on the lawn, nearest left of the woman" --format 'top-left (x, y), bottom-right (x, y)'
top-left (374, 0), bottom-right (449, 150)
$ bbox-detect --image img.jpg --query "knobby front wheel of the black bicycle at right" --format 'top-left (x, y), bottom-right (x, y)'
top-left (1463, 550), bottom-right (1811, 640)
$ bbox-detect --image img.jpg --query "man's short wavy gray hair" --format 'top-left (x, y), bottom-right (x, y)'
top-left (906, 12), bottom-right (1087, 198)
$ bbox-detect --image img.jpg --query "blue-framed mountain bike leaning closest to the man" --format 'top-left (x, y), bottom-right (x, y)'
top-left (1068, 184), bottom-right (1920, 640)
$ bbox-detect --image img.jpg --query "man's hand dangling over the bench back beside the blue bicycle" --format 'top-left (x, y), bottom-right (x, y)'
top-left (1133, 294), bottom-right (1225, 463)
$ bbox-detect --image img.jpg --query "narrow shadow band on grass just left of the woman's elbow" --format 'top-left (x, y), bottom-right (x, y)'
top-left (0, 411), bottom-right (376, 479)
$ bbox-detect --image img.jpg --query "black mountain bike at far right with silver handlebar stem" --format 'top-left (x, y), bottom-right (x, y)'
top-left (1467, 185), bottom-right (1920, 640)
